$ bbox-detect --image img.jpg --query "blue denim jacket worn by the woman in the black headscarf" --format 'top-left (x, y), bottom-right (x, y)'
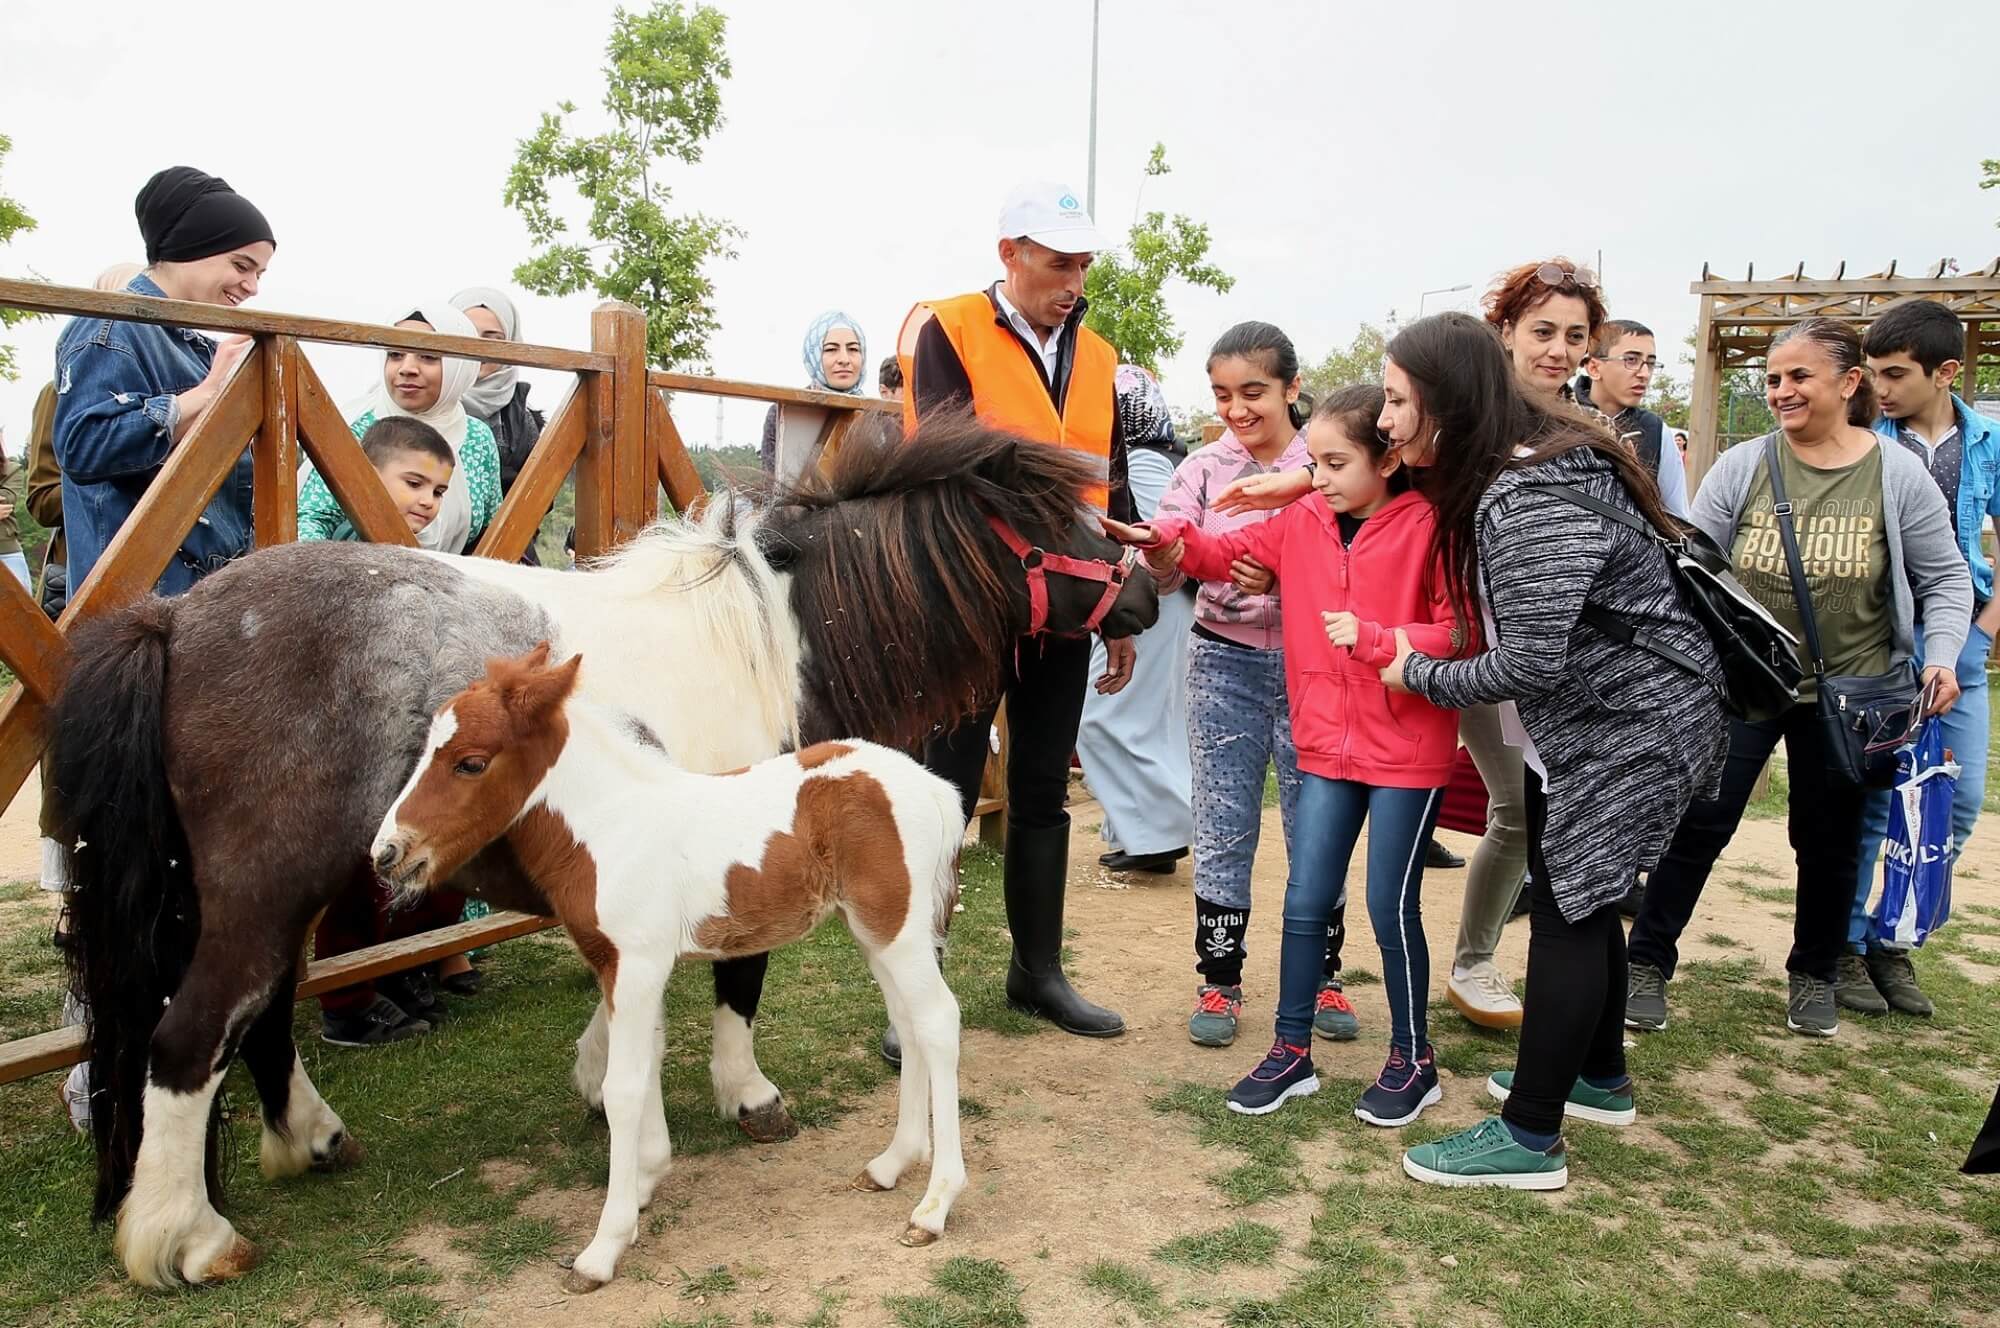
top-left (54, 274), bottom-right (252, 594)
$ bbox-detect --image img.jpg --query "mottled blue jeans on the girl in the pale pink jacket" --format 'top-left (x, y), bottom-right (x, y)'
top-left (1188, 634), bottom-right (1304, 908)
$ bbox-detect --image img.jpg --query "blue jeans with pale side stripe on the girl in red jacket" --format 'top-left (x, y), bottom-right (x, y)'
top-left (1278, 774), bottom-right (1442, 1060)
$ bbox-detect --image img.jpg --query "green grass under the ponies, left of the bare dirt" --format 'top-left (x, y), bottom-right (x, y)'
top-left (0, 850), bottom-right (1038, 1328)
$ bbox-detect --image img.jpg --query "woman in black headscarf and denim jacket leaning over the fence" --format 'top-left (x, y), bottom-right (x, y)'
top-left (54, 166), bottom-right (278, 594)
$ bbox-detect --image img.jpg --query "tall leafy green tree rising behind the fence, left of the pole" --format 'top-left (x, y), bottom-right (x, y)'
top-left (502, 0), bottom-right (742, 368)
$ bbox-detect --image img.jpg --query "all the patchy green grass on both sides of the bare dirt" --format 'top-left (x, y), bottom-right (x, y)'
top-left (0, 824), bottom-right (2000, 1328)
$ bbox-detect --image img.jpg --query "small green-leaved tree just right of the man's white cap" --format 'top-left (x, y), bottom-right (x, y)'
top-left (1084, 144), bottom-right (1236, 374)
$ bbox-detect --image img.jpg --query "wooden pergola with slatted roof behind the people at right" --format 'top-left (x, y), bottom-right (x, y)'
top-left (1688, 258), bottom-right (2000, 492)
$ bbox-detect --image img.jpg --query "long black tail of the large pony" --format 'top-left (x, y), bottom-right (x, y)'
top-left (44, 596), bottom-right (204, 1220)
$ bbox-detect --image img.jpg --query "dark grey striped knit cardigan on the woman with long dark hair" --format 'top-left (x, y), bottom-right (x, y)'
top-left (1404, 448), bottom-right (1728, 922)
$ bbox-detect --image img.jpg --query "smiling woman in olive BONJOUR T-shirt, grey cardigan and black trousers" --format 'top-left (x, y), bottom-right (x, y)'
top-left (1626, 318), bottom-right (1984, 1038)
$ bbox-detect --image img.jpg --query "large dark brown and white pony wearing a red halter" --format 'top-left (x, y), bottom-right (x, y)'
top-left (48, 422), bottom-right (1158, 1286)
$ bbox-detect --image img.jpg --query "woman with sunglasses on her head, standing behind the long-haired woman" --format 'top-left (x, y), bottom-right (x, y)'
top-left (1216, 258), bottom-right (1604, 1028)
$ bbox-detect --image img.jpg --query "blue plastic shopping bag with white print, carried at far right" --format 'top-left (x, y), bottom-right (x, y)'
top-left (1870, 716), bottom-right (1958, 948)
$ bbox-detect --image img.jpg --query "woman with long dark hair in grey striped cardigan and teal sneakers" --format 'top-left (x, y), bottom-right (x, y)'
top-left (1382, 314), bottom-right (1726, 1190)
